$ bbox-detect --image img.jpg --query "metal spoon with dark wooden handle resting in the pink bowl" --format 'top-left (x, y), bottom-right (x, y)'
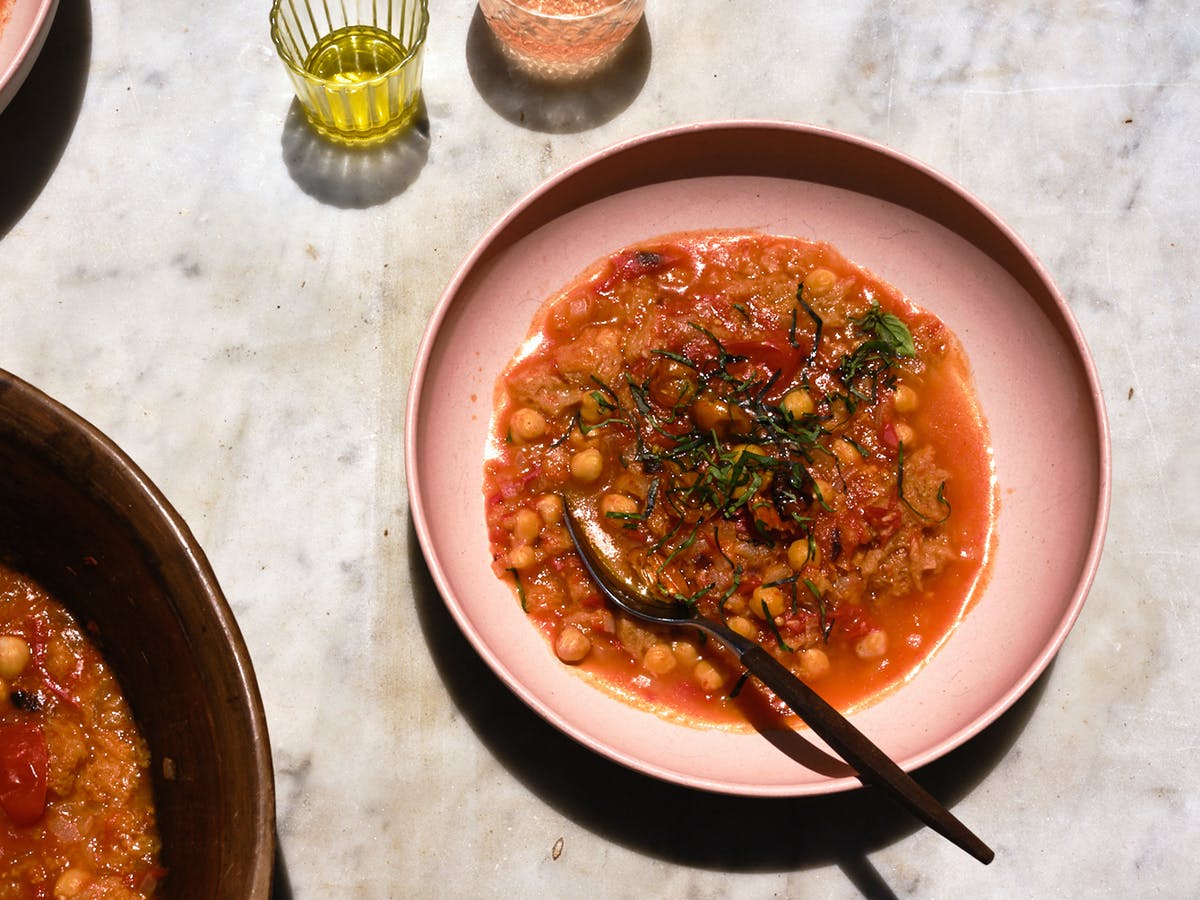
top-left (562, 496), bottom-right (995, 864)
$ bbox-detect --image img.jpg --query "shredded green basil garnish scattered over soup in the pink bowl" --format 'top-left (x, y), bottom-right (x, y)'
top-left (549, 274), bottom-right (950, 653)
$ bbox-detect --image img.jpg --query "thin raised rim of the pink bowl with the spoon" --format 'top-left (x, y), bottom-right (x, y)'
top-left (406, 120), bottom-right (1111, 796)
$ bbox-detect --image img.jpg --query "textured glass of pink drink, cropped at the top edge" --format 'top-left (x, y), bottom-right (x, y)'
top-left (479, 0), bottom-right (646, 79)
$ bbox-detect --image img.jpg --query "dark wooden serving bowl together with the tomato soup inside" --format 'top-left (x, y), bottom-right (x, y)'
top-left (0, 371), bottom-right (275, 898)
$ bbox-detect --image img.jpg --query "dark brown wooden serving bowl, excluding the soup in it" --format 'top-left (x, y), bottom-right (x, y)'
top-left (0, 371), bottom-right (275, 899)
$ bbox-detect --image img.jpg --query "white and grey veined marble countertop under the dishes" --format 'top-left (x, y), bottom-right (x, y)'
top-left (0, 0), bottom-right (1200, 898)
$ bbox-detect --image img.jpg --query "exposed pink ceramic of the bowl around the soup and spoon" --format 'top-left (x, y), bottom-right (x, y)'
top-left (406, 121), bottom-right (1110, 796)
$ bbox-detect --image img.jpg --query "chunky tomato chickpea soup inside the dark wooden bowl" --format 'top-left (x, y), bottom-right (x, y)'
top-left (0, 566), bottom-right (164, 900)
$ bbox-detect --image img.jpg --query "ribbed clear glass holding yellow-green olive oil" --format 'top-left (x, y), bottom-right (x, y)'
top-left (271, 0), bottom-right (430, 144)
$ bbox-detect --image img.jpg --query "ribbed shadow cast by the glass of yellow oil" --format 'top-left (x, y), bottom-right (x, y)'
top-left (280, 97), bottom-right (430, 209)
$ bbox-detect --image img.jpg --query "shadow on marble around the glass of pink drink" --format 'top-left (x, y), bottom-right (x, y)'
top-left (466, 6), bottom-right (652, 134)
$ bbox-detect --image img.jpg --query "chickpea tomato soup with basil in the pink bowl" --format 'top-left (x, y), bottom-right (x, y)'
top-left (484, 232), bottom-right (996, 726)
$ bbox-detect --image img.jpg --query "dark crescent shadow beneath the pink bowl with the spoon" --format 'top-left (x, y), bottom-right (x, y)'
top-left (409, 520), bottom-right (1052, 898)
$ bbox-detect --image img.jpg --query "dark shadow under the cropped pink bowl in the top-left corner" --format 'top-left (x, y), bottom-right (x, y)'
top-left (0, 0), bottom-right (91, 238)
